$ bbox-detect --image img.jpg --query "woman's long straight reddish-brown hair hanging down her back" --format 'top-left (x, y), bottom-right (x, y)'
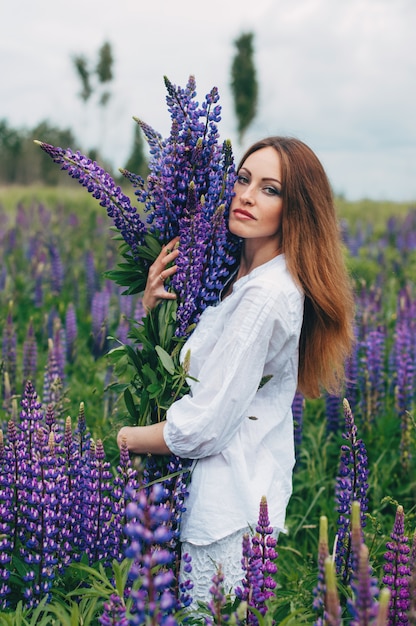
top-left (240, 137), bottom-right (354, 398)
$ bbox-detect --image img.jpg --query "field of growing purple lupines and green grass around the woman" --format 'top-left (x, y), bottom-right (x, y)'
top-left (0, 182), bottom-right (416, 625)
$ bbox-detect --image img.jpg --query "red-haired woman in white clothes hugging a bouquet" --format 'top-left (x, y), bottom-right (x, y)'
top-left (119, 137), bottom-right (353, 602)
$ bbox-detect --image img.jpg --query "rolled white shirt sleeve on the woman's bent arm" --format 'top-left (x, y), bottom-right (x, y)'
top-left (164, 285), bottom-right (300, 459)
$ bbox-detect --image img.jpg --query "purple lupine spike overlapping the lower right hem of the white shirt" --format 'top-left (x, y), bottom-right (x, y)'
top-left (235, 496), bottom-right (277, 626)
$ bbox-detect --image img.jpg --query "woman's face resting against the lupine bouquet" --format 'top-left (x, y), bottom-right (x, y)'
top-left (229, 146), bottom-right (283, 248)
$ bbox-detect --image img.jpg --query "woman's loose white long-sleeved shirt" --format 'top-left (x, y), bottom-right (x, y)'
top-left (164, 255), bottom-right (304, 545)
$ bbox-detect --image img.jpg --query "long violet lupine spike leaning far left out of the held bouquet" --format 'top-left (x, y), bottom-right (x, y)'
top-left (35, 141), bottom-right (146, 255)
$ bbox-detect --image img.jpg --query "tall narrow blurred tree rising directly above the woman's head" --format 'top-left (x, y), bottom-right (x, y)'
top-left (231, 33), bottom-right (258, 144)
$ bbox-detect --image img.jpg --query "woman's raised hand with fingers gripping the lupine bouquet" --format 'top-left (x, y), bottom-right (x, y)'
top-left (142, 237), bottom-right (179, 311)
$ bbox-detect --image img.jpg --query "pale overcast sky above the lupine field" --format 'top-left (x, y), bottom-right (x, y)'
top-left (0, 0), bottom-right (416, 203)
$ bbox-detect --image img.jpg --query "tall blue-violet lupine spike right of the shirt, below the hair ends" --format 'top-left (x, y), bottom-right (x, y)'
top-left (335, 398), bottom-right (368, 582)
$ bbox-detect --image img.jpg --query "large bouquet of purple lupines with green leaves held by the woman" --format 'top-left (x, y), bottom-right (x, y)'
top-left (38, 76), bottom-right (239, 425)
